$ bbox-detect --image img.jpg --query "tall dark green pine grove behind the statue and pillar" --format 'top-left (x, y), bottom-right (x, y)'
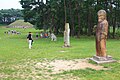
top-left (20, 0), bottom-right (120, 38)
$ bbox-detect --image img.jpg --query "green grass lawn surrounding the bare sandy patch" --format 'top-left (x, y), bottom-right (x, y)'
top-left (0, 26), bottom-right (120, 80)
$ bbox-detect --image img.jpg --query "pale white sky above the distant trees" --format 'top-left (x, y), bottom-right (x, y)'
top-left (0, 0), bottom-right (22, 9)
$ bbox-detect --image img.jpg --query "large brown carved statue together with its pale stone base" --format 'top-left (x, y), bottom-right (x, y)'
top-left (90, 10), bottom-right (116, 64)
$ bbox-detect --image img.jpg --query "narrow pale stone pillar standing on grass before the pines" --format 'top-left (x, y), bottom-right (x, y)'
top-left (64, 23), bottom-right (70, 47)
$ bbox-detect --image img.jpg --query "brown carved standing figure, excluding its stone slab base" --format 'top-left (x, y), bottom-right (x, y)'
top-left (96, 10), bottom-right (108, 57)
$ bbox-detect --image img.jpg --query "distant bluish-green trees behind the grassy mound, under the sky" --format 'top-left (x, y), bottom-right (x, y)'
top-left (0, 8), bottom-right (23, 24)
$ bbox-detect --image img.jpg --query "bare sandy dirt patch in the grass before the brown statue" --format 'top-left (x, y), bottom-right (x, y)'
top-left (36, 59), bottom-right (106, 74)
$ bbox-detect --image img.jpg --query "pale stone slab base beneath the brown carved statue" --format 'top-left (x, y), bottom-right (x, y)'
top-left (90, 55), bottom-right (116, 64)
